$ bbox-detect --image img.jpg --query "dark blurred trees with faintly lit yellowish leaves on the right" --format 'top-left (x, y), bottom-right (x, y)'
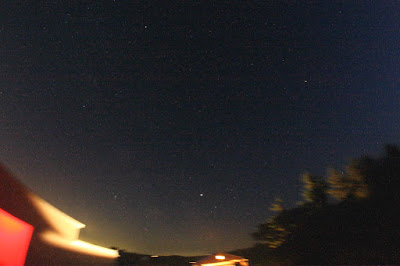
top-left (239, 145), bottom-right (400, 264)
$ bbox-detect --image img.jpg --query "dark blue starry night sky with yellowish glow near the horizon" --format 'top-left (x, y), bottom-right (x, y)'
top-left (0, 0), bottom-right (400, 255)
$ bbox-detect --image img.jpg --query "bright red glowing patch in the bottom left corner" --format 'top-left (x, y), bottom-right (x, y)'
top-left (0, 209), bottom-right (33, 265)
